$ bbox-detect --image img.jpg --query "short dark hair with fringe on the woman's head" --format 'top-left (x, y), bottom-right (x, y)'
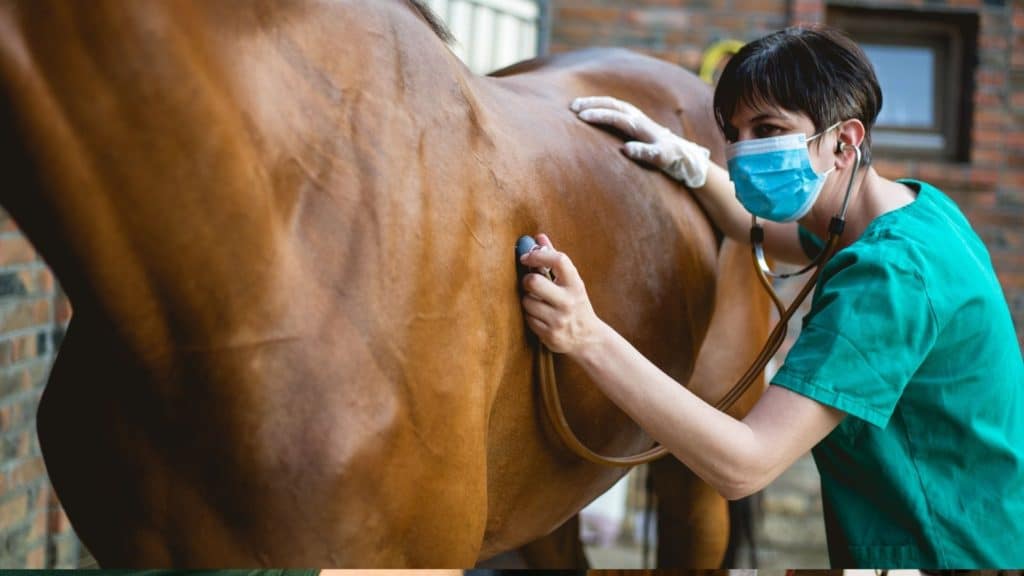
top-left (715, 26), bottom-right (882, 164)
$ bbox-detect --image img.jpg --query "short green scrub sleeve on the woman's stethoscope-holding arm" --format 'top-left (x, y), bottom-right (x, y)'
top-left (772, 238), bottom-right (937, 427)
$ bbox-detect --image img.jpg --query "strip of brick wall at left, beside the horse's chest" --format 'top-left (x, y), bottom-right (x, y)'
top-left (0, 211), bottom-right (79, 568)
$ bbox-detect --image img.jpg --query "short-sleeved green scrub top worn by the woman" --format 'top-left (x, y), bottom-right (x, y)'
top-left (772, 180), bottom-right (1024, 569)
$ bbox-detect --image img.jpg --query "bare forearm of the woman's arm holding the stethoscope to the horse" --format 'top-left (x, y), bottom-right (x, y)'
top-left (574, 317), bottom-right (775, 499)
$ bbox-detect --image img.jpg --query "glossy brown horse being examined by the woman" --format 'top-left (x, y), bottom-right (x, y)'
top-left (0, 0), bottom-right (770, 567)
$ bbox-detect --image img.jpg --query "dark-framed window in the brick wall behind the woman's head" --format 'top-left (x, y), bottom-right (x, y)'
top-left (826, 6), bottom-right (978, 161)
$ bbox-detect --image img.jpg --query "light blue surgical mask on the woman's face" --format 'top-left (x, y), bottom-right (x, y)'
top-left (726, 123), bottom-right (840, 222)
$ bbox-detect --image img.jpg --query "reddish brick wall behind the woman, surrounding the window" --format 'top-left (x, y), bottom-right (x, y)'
top-left (551, 0), bottom-right (1024, 345)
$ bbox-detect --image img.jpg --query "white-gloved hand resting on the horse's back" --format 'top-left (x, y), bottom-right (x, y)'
top-left (569, 96), bottom-right (711, 188)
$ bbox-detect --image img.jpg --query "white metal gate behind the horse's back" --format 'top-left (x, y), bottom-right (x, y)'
top-left (427, 0), bottom-right (550, 74)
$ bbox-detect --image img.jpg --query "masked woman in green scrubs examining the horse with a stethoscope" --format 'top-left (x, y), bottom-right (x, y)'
top-left (522, 29), bottom-right (1024, 568)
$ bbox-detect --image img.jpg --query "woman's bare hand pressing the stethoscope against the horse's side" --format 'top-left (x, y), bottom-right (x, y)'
top-left (519, 234), bottom-right (603, 356)
